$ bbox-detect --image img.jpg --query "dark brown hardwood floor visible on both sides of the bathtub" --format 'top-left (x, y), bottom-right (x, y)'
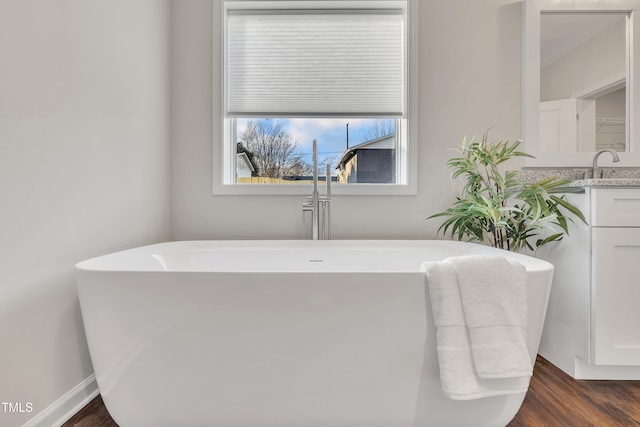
top-left (62, 356), bottom-right (640, 427)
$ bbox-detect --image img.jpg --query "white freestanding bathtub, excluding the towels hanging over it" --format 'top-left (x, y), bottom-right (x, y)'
top-left (76, 240), bottom-right (553, 427)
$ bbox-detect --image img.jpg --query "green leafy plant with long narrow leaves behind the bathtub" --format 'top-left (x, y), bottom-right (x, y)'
top-left (429, 134), bottom-right (586, 251)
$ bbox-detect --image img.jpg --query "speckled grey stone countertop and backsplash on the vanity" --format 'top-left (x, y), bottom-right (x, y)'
top-left (518, 168), bottom-right (640, 188)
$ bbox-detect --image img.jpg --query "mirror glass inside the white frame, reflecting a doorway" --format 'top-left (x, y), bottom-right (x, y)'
top-left (540, 12), bottom-right (628, 153)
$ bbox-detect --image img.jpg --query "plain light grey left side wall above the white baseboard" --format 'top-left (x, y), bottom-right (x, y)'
top-left (0, 0), bottom-right (170, 426)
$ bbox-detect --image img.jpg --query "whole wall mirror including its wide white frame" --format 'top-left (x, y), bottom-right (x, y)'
top-left (522, 0), bottom-right (640, 166)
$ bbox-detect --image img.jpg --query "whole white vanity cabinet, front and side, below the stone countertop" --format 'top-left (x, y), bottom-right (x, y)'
top-left (540, 187), bottom-right (640, 379)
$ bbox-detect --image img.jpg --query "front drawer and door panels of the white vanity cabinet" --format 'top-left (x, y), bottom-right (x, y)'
top-left (590, 188), bottom-right (640, 366)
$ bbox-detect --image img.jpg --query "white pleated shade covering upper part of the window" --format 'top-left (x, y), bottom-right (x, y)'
top-left (225, 2), bottom-right (406, 117)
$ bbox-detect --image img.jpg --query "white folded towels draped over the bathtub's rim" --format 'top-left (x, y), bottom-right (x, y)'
top-left (423, 255), bottom-right (532, 399)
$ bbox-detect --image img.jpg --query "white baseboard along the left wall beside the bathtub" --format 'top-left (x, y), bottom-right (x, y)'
top-left (22, 374), bottom-right (98, 427)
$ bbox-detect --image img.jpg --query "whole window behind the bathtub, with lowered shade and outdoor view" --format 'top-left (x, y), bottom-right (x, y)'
top-left (218, 0), bottom-right (417, 194)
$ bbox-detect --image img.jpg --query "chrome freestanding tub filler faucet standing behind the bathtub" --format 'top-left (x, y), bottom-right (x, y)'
top-left (302, 139), bottom-right (331, 240)
